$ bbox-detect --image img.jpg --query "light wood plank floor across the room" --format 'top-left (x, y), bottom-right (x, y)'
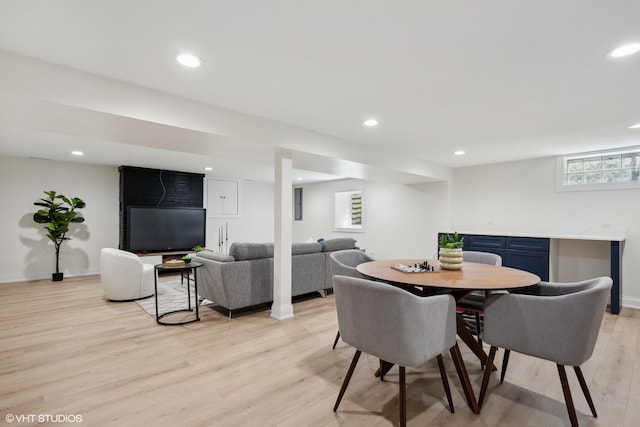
top-left (0, 277), bottom-right (640, 427)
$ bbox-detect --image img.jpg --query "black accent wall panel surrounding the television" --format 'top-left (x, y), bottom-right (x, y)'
top-left (118, 166), bottom-right (204, 250)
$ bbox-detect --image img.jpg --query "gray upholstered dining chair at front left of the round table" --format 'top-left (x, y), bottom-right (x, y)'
top-left (333, 276), bottom-right (464, 426)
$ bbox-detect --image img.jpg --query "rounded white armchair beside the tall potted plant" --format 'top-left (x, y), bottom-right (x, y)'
top-left (100, 248), bottom-right (154, 301)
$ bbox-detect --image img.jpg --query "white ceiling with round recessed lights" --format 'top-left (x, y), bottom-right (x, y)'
top-left (0, 0), bottom-right (640, 181)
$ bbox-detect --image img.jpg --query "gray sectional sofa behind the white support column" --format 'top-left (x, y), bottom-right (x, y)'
top-left (193, 238), bottom-right (356, 311)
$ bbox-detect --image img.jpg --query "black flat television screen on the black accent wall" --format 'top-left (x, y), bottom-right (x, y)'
top-left (127, 206), bottom-right (207, 252)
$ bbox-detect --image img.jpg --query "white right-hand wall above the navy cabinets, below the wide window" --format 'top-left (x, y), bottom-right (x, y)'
top-left (451, 157), bottom-right (640, 308)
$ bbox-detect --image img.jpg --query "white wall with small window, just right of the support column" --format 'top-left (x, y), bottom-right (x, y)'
top-left (293, 180), bottom-right (449, 259)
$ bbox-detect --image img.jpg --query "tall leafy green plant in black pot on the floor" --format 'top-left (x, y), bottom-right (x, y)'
top-left (33, 191), bottom-right (86, 282)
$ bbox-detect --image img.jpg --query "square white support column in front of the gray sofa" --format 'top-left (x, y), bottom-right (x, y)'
top-left (271, 151), bottom-right (293, 320)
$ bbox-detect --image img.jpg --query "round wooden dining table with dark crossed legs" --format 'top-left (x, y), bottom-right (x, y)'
top-left (356, 259), bottom-right (540, 413)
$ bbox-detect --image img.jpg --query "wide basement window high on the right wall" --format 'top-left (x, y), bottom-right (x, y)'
top-left (556, 147), bottom-right (640, 191)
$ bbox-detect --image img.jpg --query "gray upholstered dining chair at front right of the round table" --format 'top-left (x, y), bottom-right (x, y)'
top-left (478, 277), bottom-right (613, 426)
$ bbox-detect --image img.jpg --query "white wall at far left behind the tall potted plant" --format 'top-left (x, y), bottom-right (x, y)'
top-left (0, 157), bottom-right (119, 282)
